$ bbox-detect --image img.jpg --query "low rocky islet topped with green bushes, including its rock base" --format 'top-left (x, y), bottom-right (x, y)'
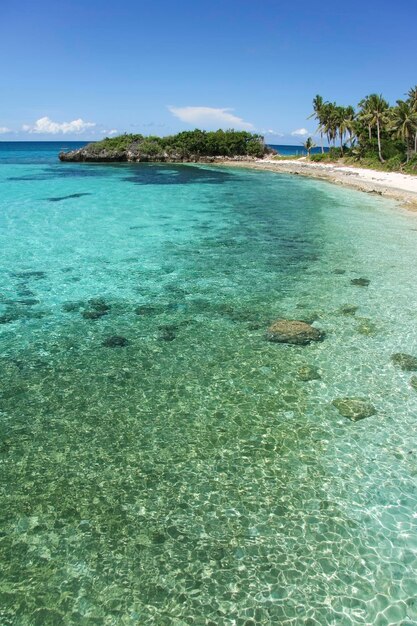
top-left (59, 129), bottom-right (276, 163)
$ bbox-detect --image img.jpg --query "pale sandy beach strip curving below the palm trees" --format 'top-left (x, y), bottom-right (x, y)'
top-left (216, 157), bottom-right (417, 211)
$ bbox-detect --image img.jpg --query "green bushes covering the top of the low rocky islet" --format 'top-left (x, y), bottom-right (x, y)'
top-left (88, 129), bottom-right (268, 159)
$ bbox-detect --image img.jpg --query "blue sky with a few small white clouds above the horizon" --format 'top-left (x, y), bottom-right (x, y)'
top-left (0, 0), bottom-right (417, 145)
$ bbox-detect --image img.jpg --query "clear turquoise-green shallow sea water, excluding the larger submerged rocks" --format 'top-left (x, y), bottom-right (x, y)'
top-left (0, 144), bottom-right (417, 626)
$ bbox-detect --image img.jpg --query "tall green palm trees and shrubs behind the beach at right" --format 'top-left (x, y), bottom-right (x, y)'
top-left (305, 86), bottom-right (417, 174)
